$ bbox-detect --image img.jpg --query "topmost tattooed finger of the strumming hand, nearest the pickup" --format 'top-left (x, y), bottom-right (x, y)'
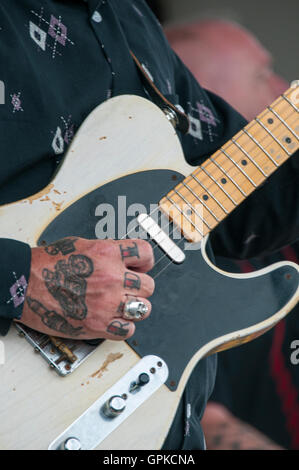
top-left (116, 239), bottom-right (154, 273)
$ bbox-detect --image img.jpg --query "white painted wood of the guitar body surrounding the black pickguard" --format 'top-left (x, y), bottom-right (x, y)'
top-left (0, 96), bottom-right (298, 450)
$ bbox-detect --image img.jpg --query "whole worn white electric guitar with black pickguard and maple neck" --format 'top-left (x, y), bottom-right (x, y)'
top-left (0, 82), bottom-right (299, 450)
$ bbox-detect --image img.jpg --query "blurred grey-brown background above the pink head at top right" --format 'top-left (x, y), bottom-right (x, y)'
top-left (148, 0), bottom-right (299, 81)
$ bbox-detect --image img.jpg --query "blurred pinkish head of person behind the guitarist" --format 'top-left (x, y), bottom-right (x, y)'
top-left (165, 20), bottom-right (288, 120)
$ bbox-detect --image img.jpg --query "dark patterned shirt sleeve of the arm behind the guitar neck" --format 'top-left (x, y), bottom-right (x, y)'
top-left (173, 54), bottom-right (299, 259)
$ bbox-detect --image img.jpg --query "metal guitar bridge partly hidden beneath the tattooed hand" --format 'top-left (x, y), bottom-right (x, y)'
top-left (15, 323), bottom-right (104, 376)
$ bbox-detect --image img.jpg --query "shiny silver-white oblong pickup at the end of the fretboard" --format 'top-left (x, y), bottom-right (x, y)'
top-left (137, 214), bottom-right (186, 264)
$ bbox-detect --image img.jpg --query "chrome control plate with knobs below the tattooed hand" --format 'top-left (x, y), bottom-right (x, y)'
top-left (48, 356), bottom-right (168, 450)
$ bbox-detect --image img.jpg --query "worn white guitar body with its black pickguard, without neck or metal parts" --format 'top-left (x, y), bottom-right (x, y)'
top-left (0, 96), bottom-right (299, 450)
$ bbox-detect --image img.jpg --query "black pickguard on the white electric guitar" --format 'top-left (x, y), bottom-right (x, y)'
top-left (39, 170), bottom-right (298, 390)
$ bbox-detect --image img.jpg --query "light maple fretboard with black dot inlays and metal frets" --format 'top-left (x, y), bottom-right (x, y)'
top-left (159, 82), bottom-right (299, 242)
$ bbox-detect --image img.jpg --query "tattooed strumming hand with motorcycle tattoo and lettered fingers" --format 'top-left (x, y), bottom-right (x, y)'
top-left (20, 237), bottom-right (154, 340)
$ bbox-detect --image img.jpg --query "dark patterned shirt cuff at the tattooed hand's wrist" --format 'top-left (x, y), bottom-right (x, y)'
top-left (0, 238), bottom-right (31, 335)
